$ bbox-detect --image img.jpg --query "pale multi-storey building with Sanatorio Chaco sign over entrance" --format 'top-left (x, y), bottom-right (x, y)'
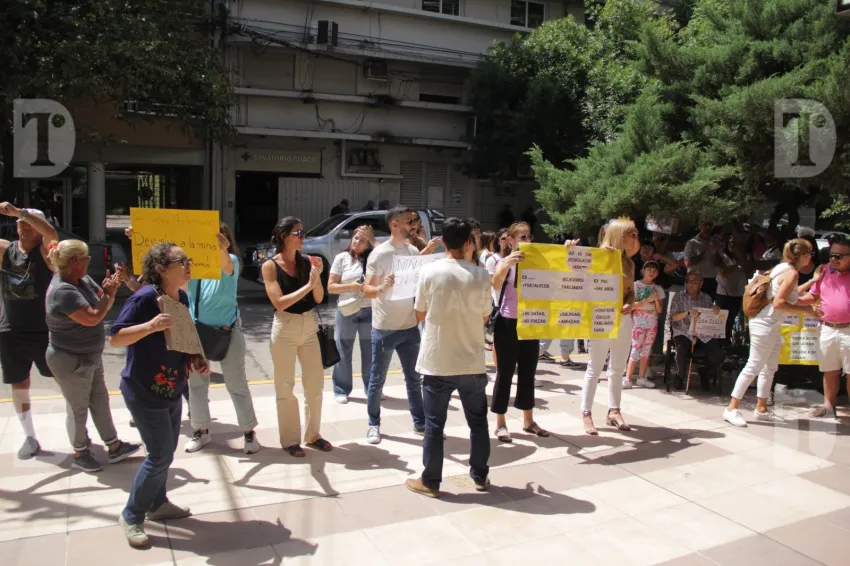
top-left (217, 0), bottom-right (583, 241)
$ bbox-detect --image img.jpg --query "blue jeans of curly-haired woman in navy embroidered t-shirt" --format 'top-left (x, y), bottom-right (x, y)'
top-left (121, 397), bottom-right (183, 525)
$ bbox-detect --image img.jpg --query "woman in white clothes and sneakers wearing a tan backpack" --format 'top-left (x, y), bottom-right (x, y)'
top-left (723, 238), bottom-right (814, 426)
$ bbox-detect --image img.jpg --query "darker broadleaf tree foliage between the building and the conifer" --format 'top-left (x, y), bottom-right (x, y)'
top-left (470, 0), bottom-right (674, 178)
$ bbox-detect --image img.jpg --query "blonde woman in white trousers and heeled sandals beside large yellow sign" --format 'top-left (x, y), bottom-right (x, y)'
top-left (581, 218), bottom-right (640, 436)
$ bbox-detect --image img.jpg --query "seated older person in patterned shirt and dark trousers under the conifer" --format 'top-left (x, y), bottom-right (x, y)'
top-left (670, 270), bottom-right (726, 391)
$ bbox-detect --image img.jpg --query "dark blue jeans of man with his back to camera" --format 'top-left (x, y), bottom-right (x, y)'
top-left (422, 373), bottom-right (490, 489)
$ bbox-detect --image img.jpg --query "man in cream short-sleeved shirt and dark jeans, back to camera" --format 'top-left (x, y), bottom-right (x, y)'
top-left (405, 218), bottom-right (492, 497)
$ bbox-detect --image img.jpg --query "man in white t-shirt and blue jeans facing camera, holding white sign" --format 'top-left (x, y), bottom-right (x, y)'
top-left (363, 205), bottom-right (425, 444)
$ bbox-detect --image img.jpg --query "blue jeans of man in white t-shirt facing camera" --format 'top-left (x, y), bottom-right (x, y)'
top-left (366, 326), bottom-right (425, 427)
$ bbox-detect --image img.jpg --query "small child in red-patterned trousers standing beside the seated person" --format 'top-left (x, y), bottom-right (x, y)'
top-left (623, 260), bottom-right (664, 389)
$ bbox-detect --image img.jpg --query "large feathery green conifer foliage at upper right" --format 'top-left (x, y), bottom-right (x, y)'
top-left (530, 0), bottom-right (850, 237)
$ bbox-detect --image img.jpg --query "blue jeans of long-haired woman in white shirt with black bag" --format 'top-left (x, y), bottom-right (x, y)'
top-left (333, 308), bottom-right (372, 397)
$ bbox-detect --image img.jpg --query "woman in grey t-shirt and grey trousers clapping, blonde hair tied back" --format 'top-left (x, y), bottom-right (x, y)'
top-left (45, 240), bottom-right (141, 472)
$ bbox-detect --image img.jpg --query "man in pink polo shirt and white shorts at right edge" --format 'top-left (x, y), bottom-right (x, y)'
top-left (798, 234), bottom-right (850, 417)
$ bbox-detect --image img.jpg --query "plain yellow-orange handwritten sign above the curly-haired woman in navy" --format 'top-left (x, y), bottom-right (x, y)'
top-left (130, 208), bottom-right (221, 279)
